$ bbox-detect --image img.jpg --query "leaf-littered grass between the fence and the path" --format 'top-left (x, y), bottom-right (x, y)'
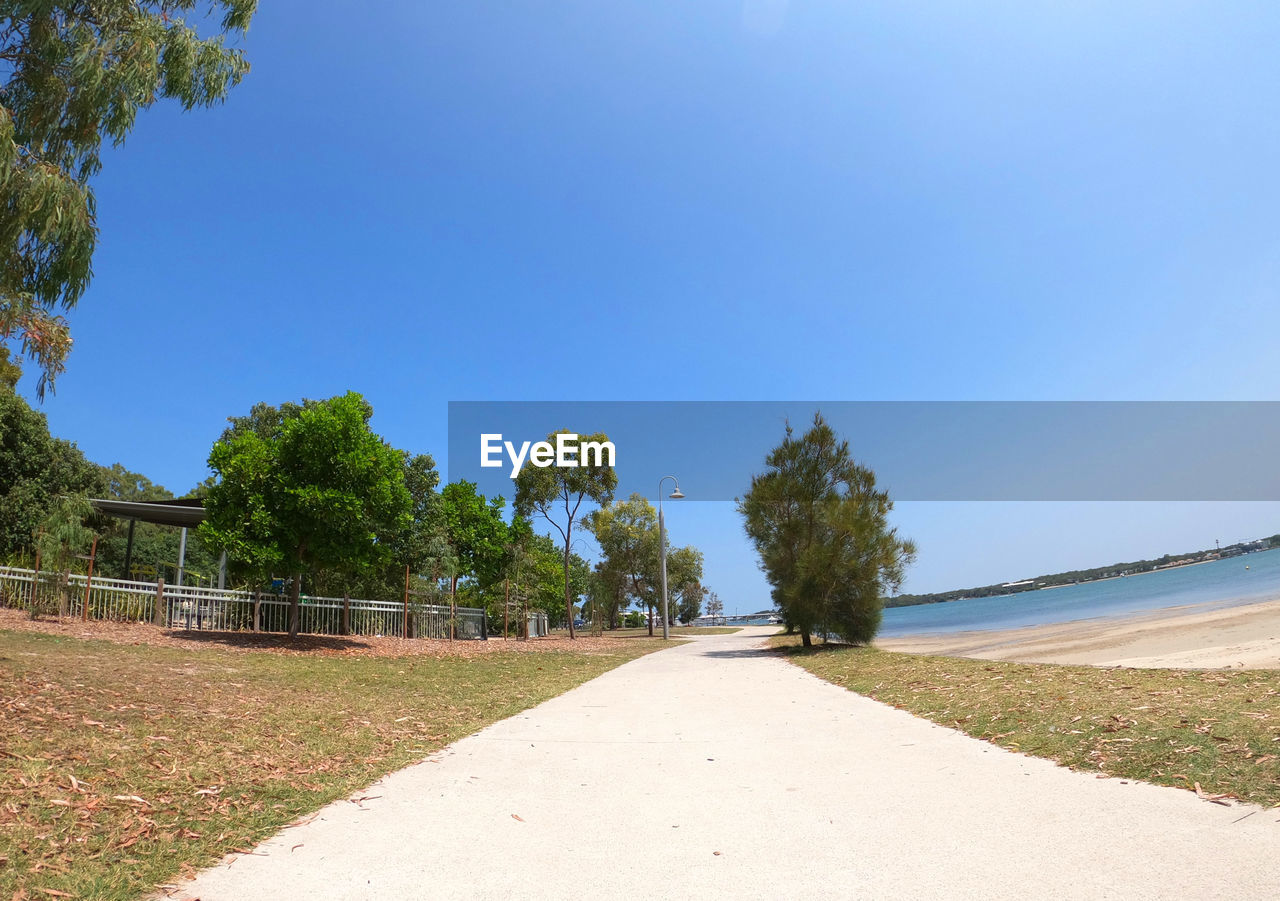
top-left (0, 632), bottom-right (662, 898)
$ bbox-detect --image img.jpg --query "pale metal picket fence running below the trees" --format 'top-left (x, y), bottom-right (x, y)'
top-left (0, 567), bottom-right (488, 639)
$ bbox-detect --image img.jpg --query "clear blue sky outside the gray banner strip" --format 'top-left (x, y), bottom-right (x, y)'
top-left (15, 0), bottom-right (1280, 610)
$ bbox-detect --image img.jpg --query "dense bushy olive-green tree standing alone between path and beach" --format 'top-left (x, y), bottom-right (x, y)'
top-left (739, 413), bottom-right (915, 648)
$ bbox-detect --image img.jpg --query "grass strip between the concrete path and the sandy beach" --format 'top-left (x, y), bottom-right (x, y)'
top-left (772, 636), bottom-right (1280, 805)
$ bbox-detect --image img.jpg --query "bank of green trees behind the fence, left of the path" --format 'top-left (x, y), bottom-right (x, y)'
top-left (0, 368), bottom-right (701, 632)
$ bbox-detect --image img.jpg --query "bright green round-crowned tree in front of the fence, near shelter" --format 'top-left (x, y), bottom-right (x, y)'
top-left (200, 392), bottom-right (411, 636)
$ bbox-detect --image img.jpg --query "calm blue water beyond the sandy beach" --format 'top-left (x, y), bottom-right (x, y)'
top-left (879, 548), bottom-right (1280, 636)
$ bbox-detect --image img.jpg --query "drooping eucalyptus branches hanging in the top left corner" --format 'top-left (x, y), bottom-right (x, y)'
top-left (0, 0), bottom-right (257, 395)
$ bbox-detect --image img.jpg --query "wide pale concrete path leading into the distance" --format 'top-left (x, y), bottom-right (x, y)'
top-left (177, 630), bottom-right (1280, 901)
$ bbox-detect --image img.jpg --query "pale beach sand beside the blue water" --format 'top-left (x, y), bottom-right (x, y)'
top-left (876, 599), bottom-right (1280, 669)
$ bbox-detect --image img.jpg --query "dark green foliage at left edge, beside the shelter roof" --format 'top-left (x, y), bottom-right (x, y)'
top-left (0, 387), bottom-right (101, 559)
